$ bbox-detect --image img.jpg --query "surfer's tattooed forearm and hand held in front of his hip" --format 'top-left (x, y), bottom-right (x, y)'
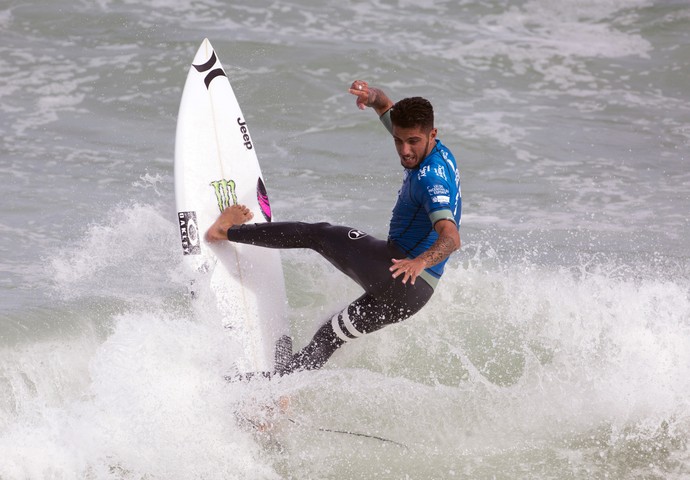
top-left (389, 220), bottom-right (460, 285)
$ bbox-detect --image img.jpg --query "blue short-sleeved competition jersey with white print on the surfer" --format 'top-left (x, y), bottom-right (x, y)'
top-left (388, 140), bottom-right (462, 286)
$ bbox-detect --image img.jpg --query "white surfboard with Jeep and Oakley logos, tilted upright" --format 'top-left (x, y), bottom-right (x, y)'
top-left (175, 39), bottom-right (291, 374)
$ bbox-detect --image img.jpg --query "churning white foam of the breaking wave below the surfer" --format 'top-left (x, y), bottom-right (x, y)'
top-left (6, 238), bottom-right (690, 478)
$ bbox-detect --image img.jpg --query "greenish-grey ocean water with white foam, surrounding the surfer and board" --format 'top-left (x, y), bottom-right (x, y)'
top-left (0, 0), bottom-right (690, 480)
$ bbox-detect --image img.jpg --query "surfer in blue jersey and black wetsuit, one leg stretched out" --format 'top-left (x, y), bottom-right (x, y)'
top-left (206, 80), bottom-right (462, 375)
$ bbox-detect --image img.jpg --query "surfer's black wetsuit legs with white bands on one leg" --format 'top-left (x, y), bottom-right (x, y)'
top-left (228, 222), bottom-right (434, 374)
